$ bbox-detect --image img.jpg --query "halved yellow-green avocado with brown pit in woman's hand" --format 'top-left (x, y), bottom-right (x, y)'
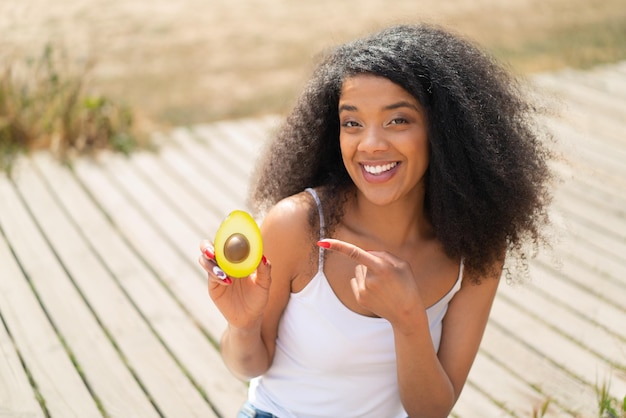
top-left (213, 210), bottom-right (263, 278)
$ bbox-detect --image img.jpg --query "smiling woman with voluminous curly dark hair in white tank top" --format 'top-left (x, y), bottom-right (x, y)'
top-left (200, 25), bottom-right (550, 418)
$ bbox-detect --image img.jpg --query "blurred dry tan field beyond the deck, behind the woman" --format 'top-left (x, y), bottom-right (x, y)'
top-left (0, 0), bottom-right (626, 127)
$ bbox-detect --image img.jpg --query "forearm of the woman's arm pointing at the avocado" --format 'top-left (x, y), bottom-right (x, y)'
top-left (394, 312), bottom-right (456, 418)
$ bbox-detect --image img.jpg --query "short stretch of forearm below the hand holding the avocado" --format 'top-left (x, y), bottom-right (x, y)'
top-left (221, 322), bottom-right (270, 380)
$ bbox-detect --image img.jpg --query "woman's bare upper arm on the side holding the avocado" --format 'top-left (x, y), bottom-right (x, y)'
top-left (261, 195), bottom-right (311, 364)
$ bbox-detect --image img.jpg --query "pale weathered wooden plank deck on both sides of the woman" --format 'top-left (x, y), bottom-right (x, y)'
top-left (0, 64), bottom-right (626, 418)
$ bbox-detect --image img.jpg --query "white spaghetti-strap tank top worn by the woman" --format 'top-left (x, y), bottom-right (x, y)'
top-left (249, 189), bottom-right (463, 418)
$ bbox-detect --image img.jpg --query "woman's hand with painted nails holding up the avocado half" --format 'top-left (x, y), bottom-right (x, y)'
top-left (198, 240), bottom-right (271, 329)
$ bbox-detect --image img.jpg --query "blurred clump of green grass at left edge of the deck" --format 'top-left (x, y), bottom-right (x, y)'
top-left (0, 45), bottom-right (145, 171)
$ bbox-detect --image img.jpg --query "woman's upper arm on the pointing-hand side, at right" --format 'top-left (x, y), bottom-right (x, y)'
top-left (437, 265), bottom-right (502, 398)
